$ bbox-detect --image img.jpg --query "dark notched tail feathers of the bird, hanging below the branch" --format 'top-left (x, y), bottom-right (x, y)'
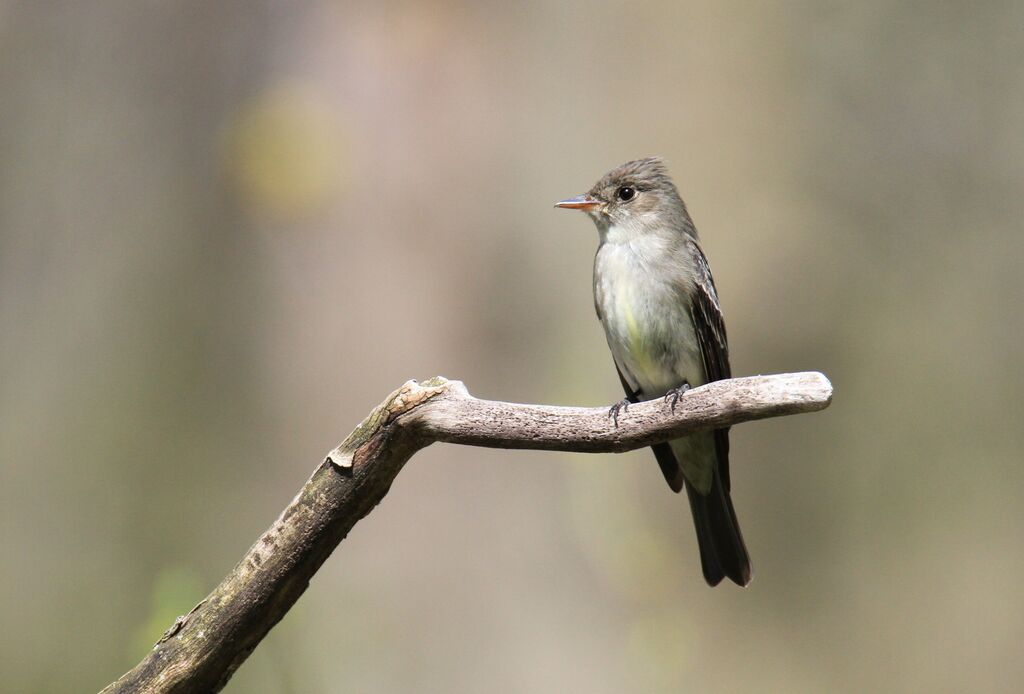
top-left (686, 466), bottom-right (754, 585)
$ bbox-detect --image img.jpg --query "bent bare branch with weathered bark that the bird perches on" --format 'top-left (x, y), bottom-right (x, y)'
top-left (103, 373), bottom-right (833, 694)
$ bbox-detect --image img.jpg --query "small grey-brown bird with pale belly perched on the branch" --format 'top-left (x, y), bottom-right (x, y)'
top-left (555, 157), bottom-right (753, 587)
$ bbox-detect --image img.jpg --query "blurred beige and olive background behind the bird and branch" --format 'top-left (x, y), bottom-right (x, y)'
top-left (0, 0), bottom-right (1024, 693)
